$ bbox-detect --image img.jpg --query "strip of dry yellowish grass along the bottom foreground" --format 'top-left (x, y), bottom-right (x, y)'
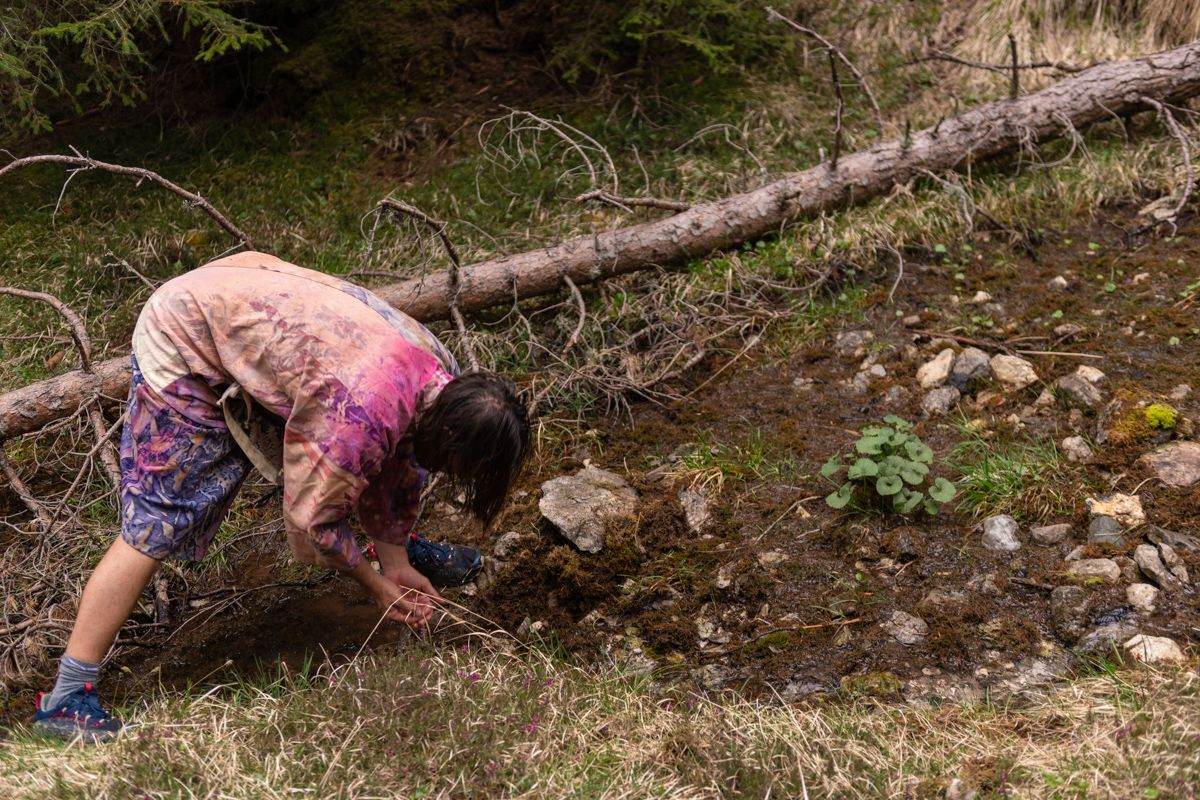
top-left (0, 639), bottom-right (1200, 800)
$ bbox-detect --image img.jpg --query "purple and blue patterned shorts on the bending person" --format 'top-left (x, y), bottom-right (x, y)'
top-left (121, 357), bottom-right (250, 561)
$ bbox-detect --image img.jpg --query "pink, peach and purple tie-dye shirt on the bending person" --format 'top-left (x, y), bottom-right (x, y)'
top-left (133, 252), bottom-right (457, 570)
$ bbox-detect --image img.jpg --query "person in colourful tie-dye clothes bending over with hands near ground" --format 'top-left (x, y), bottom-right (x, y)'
top-left (34, 252), bottom-right (529, 741)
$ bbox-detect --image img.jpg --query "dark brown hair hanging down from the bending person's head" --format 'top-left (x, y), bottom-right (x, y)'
top-left (413, 372), bottom-right (529, 523)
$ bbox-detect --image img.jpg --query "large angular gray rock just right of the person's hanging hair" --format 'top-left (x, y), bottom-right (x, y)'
top-left (538, 467), bottom-right (637, 553)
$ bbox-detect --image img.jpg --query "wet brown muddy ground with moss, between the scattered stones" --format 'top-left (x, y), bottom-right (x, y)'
top-left (9, 211), bottom-right (1200, 719)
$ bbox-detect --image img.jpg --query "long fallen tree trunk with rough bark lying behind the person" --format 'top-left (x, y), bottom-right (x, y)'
top-left (0, 42), bottom-right (1200, 441)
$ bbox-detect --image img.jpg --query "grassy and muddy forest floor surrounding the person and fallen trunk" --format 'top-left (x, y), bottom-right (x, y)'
top-left (0, 4), bottom-right (1200, 798)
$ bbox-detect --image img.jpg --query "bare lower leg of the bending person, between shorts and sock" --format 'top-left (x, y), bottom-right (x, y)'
top-left (66, 536), bottom-right (158, 663)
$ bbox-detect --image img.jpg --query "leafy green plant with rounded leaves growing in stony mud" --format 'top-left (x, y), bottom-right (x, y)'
top-left (821, 415), bottom-right (955, 515)
